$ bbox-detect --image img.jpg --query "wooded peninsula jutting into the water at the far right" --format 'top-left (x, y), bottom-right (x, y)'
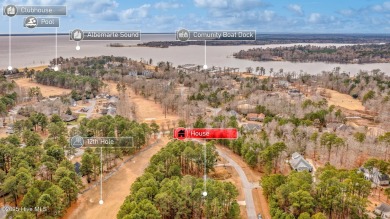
top-left (233, 44), bottom-right (390, 64)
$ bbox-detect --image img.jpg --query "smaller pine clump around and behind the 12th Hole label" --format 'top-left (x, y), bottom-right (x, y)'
top-left (77, 115), bottom-right (154, 183)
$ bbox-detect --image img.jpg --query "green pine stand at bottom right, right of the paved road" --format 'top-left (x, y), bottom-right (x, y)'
top-left (261, 165), bottom-right (371, 219)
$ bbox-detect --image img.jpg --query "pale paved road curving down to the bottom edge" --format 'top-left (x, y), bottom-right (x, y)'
top-left (217, 149), bottom-right (257, 219)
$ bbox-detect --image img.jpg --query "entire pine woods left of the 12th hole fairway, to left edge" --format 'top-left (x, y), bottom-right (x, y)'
top-left (0, 112), bottom-right (151, 219)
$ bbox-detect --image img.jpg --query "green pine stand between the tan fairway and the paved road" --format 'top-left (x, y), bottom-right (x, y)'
top-left (117, 141), bottom-right (240, 219)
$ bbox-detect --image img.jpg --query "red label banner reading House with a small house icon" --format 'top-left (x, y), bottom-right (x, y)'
top-left (173, 128), bottom-right (238, 140)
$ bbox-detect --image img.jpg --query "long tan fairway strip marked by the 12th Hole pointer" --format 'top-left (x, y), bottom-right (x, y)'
top-left (63, 137), bottom-right (169, 219)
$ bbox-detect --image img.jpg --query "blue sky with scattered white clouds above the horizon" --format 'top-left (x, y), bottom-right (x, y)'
top-left (0, 0), bottom-right (390, 34)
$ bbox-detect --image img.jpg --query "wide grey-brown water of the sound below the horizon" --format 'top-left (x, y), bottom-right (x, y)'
top-left (0, 41), bottom-right (390, 75)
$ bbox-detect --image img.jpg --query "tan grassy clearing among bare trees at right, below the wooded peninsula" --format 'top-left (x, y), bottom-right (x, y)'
top-left (322, 89), bottom-right (365, 111)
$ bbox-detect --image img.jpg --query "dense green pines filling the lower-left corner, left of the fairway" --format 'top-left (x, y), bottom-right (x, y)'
top-left (0, 113), bottom-right (82, 219)
